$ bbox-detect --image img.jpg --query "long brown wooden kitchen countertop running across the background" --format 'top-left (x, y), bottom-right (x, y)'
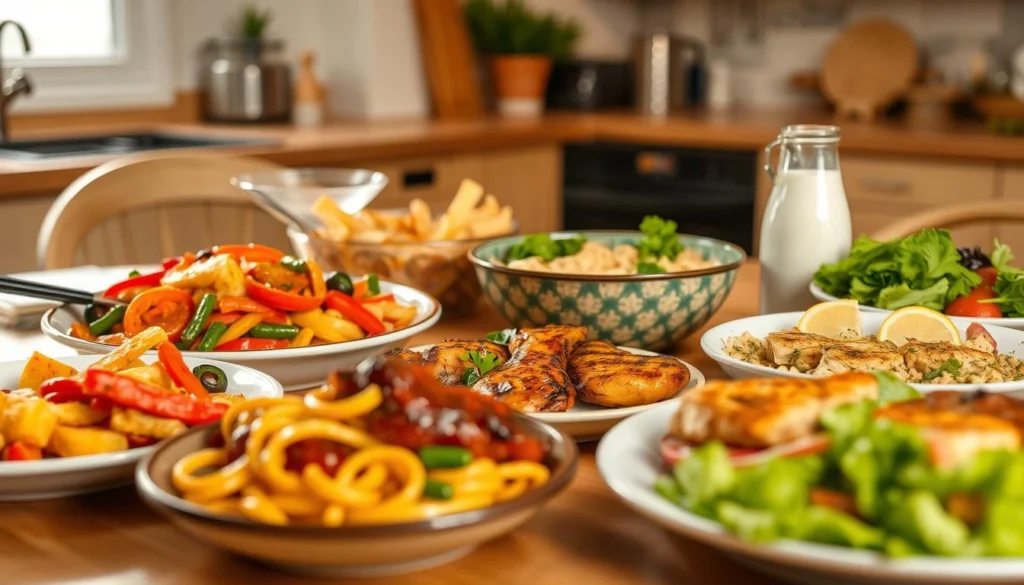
top-left (0, 109), bottom-right (1024, 198)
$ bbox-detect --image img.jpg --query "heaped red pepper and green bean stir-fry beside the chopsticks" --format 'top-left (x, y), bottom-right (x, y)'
top-left (70, 244), bottom-right (418, 350)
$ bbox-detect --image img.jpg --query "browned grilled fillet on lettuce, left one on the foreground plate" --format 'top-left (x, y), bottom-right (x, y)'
top-left (669, 373), bottom-right (879, 449)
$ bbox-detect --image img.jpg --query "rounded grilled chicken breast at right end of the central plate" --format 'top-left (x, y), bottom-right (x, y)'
top-left (568, 341), bottom-right (690, 408)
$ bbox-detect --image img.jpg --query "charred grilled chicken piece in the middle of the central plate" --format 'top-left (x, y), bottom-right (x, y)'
top-left (473, 326), bottom-right (587, 413)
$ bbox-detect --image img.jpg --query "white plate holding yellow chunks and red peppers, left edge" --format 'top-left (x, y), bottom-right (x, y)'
top-left (0, 356), bottom-right (285, 502)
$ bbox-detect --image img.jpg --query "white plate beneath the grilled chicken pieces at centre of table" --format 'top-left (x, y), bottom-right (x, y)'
top-left (410, 345), bottom-right (706, 441)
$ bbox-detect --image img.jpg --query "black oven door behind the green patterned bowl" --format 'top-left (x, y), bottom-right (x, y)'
top-left (564, 185), bottom-right (754, 254)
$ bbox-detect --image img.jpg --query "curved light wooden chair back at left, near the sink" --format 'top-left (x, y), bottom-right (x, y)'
top-left (37, 155), bottom-right (291, 269)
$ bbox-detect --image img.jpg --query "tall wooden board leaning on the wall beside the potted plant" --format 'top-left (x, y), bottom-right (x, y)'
top-left (413, 0), bottom-right (483, 120)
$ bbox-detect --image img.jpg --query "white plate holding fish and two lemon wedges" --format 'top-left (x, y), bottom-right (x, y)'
top-left (700, 311), bottom-right (1024, 392)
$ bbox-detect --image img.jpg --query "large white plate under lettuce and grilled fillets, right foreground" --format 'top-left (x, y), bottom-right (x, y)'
top-left (597, 404), bottom-right (1024, 585)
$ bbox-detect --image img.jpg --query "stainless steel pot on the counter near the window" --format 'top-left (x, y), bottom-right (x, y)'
top-left (200, 39), bottom-right (292, 122)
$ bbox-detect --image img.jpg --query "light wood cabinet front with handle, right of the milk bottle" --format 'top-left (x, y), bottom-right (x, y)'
top-left (840, 155), bottom-right (999, 248)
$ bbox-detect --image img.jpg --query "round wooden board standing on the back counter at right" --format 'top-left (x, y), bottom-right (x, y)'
top-left (820, 18), bottom-right (920, 120)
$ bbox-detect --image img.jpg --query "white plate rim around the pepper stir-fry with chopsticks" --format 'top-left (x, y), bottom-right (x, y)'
top-left (40, 281), bottom-right (441, 363)
